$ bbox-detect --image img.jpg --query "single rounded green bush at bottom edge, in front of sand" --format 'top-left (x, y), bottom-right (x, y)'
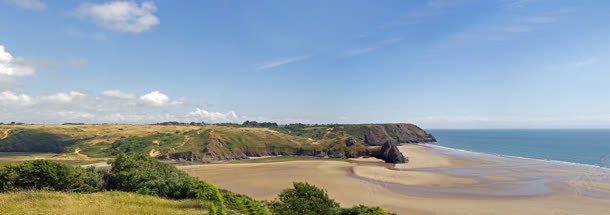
top-left (270, 182), bottom-right (339, 215)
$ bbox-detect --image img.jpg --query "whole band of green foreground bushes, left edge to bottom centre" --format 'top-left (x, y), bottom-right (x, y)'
top-left (0, 153), bottom-right (388, 215)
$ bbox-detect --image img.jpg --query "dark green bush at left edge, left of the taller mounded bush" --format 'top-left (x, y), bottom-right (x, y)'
top-left (0, 160), bottom-right (107, 192)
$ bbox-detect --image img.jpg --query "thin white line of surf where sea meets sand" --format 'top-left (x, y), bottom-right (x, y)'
top-left (425, 144), bottom-right (610, 171)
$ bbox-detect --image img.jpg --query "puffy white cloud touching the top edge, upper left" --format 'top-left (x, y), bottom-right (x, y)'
top-left (78, 1), bottom-right (160, 33)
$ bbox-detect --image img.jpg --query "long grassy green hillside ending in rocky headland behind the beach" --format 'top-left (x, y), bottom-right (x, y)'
top-left (0, 122), bottom-right (435, 162)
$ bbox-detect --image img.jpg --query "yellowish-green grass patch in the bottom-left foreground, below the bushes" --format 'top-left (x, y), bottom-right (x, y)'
top-left (0, 191), bottom-right (208, 214)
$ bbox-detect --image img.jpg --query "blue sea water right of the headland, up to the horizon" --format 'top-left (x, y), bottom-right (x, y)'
top-left (428, 129), bottom-right (610, 168)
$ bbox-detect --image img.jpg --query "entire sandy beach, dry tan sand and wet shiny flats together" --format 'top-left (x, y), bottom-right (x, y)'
top-left (180, 145), bottom-right (610, 214)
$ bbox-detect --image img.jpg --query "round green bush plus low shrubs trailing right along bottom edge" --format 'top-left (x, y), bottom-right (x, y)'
top-left (268, 182), bottom-right (388, 215)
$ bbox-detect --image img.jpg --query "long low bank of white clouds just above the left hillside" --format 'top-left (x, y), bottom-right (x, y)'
top-left (0, 90), bottom-right (197, 123)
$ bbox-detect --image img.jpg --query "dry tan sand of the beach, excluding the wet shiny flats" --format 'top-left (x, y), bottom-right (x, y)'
top-left (180, 146), bottom-right (610, 214)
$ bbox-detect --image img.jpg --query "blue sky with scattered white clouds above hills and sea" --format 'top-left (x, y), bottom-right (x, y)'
top-left (0, 0), bottom-right (610, 128)
